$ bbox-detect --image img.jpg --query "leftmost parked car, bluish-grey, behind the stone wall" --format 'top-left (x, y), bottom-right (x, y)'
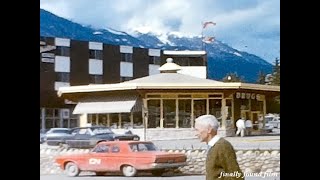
top-left (45, 128), bottom-right (72, 146)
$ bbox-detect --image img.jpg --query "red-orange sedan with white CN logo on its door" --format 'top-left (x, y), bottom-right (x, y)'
top-left (55, 141), bottom-right (187, 177)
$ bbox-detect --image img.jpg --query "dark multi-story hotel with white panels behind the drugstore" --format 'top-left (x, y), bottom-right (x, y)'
top-left (40, 37), bottom-right (207, 130)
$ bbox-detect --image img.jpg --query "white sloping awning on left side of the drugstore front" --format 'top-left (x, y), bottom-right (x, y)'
top-left (73, 95), bottom-right (142, 114)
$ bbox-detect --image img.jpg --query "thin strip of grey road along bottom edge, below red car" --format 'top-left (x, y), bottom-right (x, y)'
top-left (40, 175), bottom-right (280, 180)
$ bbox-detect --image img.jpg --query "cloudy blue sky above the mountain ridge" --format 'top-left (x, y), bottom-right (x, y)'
top-left (40, 0), bottom-right (280, 63)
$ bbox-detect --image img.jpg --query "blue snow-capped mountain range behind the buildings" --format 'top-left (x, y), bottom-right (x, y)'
top-left (40, 9), bottom-right (272, 83)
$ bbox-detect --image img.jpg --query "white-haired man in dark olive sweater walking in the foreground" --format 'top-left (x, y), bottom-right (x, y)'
top-left (195, 115), bottom-right (244, 180)
